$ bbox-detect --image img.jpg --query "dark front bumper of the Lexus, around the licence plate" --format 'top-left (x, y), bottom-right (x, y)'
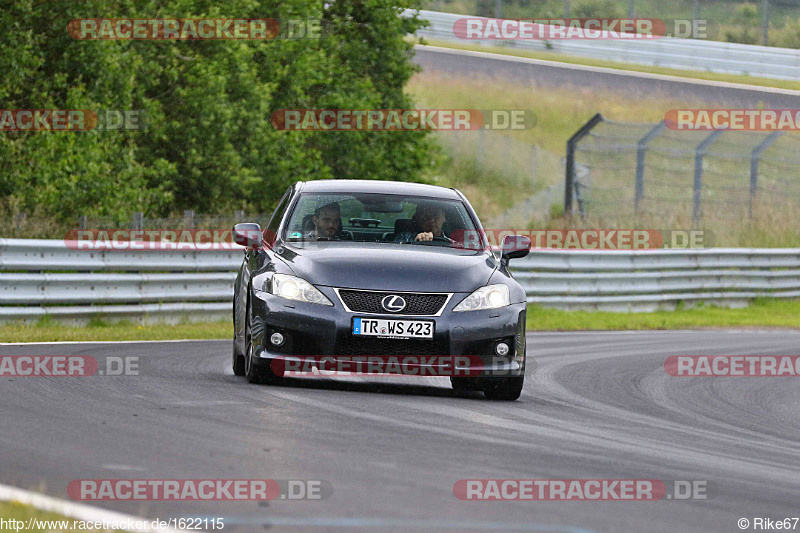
top-left (251, 286), bottom-right (526, 377)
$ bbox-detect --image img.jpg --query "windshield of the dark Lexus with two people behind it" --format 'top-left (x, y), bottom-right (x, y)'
top-left (283, 193), bottom-right (480, 248)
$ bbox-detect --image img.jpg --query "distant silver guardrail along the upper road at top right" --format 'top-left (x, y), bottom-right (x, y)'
top-left (410, 10), bottom-right (800, 80)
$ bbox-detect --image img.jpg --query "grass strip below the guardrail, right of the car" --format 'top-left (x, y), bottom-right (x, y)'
top-left (528, 299), bottom-right (800, 331)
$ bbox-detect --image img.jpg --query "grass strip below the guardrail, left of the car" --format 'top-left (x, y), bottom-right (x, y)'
top-left (0, 319), bottom-right (233, 342)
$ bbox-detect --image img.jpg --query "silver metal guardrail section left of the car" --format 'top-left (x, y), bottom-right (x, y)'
top-left (0, 239), bottom-right (242, 322)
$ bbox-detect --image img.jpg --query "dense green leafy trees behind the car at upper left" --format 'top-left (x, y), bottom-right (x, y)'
top-left (0, 0), bottom-right (432, 220)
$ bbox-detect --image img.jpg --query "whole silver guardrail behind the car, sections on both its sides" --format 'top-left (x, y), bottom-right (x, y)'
top-left (0, 239), bottom-right (800, 322)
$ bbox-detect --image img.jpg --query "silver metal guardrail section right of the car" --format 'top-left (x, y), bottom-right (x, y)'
top-left (511, 248), bottom-right (800, 311)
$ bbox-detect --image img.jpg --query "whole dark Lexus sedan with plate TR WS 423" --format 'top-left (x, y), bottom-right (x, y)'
top-left (233, 180), bottom-right (530, 400)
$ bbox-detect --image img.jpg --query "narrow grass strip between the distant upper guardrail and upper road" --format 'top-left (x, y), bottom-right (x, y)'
top-left (416, 39), bottom-right (800, 91)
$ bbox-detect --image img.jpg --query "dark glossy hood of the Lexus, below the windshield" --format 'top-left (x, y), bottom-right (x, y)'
top-left (280, 243), bottom-right (498, 292)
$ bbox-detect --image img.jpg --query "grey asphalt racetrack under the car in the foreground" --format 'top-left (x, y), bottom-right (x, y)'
top-left (0, 331), bottom-right (800, 533)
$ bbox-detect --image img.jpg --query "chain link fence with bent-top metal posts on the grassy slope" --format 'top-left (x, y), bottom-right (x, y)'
top-left (564, 114), bottom-right (800, 222)
